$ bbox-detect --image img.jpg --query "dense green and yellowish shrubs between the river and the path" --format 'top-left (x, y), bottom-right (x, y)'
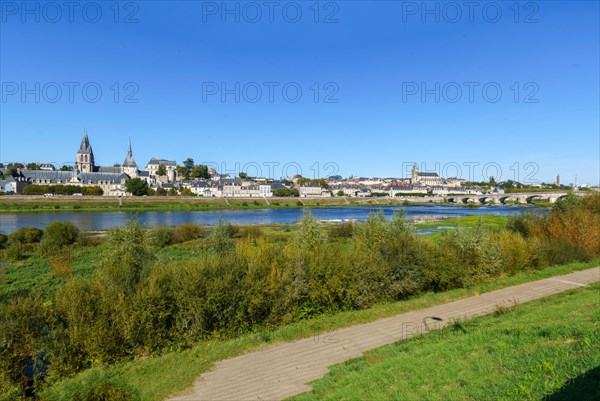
top-left (0, 194), bottom-right (600, 400)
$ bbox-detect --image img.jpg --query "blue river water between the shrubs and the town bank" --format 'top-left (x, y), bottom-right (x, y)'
top-left (0, 205), bottom-right (525, 234)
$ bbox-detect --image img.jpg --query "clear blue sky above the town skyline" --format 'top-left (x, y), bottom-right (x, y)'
top-left (0, 1), bottom-right (600, 184)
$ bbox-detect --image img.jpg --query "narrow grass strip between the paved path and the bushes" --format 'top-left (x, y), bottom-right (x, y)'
top-left (42, 260), bottom-right (600, 401)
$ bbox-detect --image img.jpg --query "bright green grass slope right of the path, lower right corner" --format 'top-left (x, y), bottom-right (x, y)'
top-left (291, 284), bottom-right (600, 401)
